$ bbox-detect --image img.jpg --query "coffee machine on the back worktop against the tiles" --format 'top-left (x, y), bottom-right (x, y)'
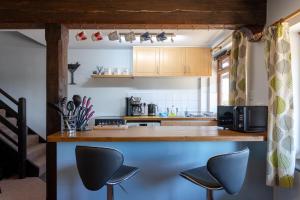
top-left (126, 97), bottom-right (146, 116)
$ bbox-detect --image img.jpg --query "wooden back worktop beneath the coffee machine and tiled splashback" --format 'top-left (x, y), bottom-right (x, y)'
top-left (123, 115), bottom-right (216, 121)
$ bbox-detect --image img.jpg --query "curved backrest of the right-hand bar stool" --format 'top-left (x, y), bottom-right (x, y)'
top-left (207, 148), bottom-right (249, 195)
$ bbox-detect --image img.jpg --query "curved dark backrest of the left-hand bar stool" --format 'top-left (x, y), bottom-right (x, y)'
top-left (75, 146), bottom-right (124, 191)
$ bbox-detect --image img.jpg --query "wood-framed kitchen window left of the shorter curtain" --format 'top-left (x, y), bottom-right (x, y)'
top-left (217, 51), bottom-right (230, 105)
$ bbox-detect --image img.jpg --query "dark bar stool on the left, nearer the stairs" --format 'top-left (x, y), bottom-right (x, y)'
top-left (75, 146), bottom-right (138, 200)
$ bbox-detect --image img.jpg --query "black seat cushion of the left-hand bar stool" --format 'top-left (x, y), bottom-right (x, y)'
top-left (107, 165), bottom-right (139, 185)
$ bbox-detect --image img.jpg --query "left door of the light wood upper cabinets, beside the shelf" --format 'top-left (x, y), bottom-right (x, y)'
top-left (133, 47), bottom-right (159, 76)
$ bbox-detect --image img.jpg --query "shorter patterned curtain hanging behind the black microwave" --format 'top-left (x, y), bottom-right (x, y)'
top-left (229, 31), bottom-right (248, 106)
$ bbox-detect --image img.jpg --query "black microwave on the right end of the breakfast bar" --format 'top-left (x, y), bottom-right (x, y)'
top-left (217, 106), bottom-right (268, 132)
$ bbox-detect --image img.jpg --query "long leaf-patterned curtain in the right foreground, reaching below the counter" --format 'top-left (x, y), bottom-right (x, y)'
top-left (264, 23), bottom-right (296, 188)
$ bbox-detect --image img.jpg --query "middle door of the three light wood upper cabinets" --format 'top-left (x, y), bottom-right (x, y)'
top-left (159, 47), bottom-right (185, 76)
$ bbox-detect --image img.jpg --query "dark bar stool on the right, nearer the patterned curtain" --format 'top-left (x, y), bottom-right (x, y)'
top-left (180, 148), bottom-right (249, 200)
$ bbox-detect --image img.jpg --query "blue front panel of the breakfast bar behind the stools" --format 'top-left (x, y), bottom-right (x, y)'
top-left (57, 142), bottom-right (273, 200)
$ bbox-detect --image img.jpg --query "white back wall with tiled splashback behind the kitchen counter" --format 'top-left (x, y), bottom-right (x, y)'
top-left (68, 49), bottom-right (208, 116)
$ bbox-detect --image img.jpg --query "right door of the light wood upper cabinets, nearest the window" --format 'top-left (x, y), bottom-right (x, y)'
top-left (185, 47), bottom-right (212, 76)
